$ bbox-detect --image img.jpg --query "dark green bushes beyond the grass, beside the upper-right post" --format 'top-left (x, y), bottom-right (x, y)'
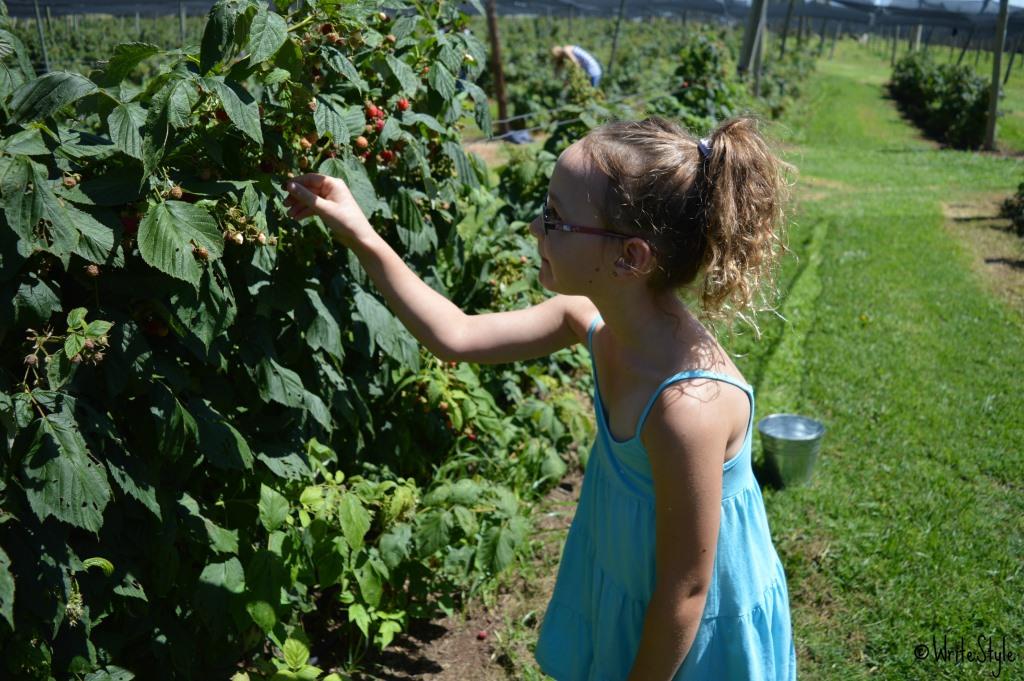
top-left (889, 52), bottom-right (990, 148)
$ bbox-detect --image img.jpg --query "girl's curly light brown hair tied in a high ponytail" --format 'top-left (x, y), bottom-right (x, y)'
top-left (583, 117), bottom-right (796, 336)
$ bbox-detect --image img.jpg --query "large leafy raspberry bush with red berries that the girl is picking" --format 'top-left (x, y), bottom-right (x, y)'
top-left (0, 0), bottom-right (591, 679)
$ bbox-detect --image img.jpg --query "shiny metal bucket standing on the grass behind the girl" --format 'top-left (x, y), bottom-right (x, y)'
top-left (758, 414), bottom-right (825, 486)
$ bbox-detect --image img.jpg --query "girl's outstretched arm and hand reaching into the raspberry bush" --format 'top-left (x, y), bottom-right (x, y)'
top-left (286, 174), bottom-right (596, 364)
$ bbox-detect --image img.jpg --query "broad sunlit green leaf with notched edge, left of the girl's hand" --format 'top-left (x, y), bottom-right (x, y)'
top-left (138, 201), bottom-right (224, 287)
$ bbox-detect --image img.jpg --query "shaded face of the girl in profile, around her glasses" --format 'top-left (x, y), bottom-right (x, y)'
top-left (529, 141), bottom-right (618, 295)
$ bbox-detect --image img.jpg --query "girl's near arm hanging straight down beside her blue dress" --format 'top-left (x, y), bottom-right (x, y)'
top-left (629, 381), bottom-right (729, 681)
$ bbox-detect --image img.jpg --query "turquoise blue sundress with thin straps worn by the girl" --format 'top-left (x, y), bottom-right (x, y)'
top-left (535, 314), bottom-right (797, 681)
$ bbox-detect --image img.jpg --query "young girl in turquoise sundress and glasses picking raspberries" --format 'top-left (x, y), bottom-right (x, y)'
top-left (288, 118), bottom-right (796, 681)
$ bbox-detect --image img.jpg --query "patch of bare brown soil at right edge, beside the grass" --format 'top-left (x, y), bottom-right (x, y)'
top-left (942, 194), bottom-right (1024, 316)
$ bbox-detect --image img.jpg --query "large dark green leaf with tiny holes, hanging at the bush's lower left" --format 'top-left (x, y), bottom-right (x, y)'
top-left (24, 408), bottom-right (111, 533)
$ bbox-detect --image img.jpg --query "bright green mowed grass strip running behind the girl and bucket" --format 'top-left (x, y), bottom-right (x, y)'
top-left (761, 44), bottom-right (1024, 681)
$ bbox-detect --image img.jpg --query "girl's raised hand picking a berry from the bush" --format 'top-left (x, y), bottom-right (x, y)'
top-left (285, 173), bottom-right (374, 248)
